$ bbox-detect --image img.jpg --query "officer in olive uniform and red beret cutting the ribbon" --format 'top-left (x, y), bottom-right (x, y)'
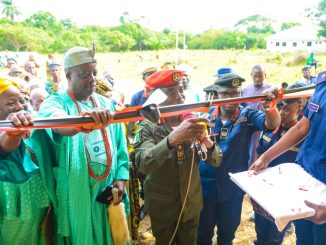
top-left (134, 70), bottom-right (221, 245)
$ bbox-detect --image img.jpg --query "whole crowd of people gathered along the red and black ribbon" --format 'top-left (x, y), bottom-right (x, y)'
top-left (0, 44), bottom-right (326, 245)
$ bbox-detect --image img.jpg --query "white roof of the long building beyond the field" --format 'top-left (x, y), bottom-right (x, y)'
top-left (266, 25), bottom-right (326, 41)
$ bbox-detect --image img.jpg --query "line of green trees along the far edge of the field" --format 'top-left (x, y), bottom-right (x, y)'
top-left (0, 0), bottom-right (326, 53)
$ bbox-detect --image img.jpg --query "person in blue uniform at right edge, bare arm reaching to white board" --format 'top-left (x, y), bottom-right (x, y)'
top-left (250, 71), bottom-right (326, 245)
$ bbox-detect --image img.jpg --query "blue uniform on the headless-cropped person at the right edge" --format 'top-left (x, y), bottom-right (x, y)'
top-left (294, 82), bottom-right (326, 245)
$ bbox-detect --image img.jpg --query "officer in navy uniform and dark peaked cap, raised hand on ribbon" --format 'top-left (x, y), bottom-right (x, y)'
top-left (197, 73), bottom-right (281, 245)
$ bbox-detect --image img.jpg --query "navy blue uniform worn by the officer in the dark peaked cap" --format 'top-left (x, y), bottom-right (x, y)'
top-left (197, 106), bottom-right (265, 245)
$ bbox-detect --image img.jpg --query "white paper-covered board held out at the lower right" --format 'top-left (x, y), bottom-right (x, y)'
top-left (229, 163), bottom-right (326, 231)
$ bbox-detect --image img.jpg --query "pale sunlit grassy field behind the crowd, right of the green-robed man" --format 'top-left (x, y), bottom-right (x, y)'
top-left (91, 50), bottom-right (326, 102)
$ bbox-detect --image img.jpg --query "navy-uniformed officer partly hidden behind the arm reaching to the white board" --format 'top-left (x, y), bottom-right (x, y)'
top-left (255, 98), bottom-right (303, 245)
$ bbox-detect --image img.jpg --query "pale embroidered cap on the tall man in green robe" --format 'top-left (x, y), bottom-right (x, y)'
top-left (63, 47), bottom-right (96, 69)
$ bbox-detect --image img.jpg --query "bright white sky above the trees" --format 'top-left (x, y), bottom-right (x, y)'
top-left (14, 0), bottom-right (319, 33)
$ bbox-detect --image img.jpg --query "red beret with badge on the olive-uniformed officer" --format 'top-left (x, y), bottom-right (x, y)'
top-left (145, 70), bottom-right (183, 90)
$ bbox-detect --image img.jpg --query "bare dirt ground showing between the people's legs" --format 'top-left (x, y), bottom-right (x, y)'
top-left (132, 196), bottom-right (295, 245)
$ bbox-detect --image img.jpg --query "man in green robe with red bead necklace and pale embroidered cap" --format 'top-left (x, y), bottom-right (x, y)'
top-left (31, 47), bottom-right (129, 245)
